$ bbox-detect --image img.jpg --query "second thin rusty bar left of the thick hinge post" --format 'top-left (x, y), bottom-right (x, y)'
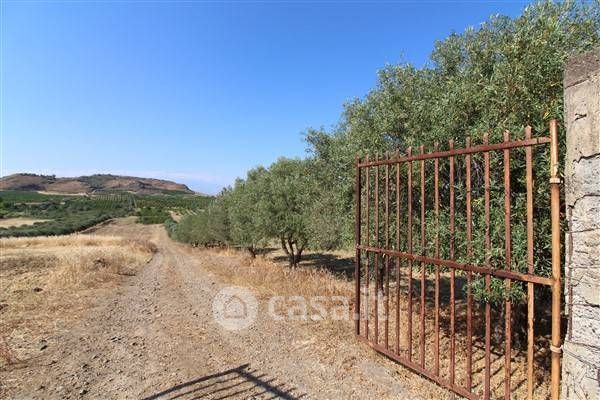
top-left (504, 131), bottom-right (512, 400)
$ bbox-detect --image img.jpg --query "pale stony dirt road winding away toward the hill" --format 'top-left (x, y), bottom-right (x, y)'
top-left (0, 223), bottom-right (438, 399)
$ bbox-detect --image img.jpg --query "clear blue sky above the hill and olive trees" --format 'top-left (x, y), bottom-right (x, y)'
top-left (0, 0), bottom-right (527, 193)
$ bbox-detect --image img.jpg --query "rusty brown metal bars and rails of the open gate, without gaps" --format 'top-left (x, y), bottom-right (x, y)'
top-left (354, 120), bottom-right (561, 400)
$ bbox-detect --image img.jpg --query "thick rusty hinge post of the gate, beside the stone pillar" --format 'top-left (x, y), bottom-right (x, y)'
top-left (550, 120), bottom-right (561, 400)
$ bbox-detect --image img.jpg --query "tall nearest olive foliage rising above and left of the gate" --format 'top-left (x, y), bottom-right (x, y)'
top-left (306, 1), bottom-right (600, 253)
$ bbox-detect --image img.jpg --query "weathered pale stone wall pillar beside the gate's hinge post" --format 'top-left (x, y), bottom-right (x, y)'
top-left (561, 49), bottom-right (600, 400)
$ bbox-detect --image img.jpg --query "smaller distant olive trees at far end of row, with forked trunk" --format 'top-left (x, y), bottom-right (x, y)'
top-left (168, 158), bottom-right (316, 265)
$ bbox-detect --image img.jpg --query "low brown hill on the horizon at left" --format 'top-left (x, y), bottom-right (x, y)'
top-left (0, 173), bottom-right (194, 194)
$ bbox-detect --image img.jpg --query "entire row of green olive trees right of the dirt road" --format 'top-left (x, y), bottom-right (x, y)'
top-left (167, 1), bottom-right (600, 301)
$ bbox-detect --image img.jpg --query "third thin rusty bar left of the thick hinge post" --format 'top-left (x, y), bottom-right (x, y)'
top-left (483, 132), bottom-right (492, 400)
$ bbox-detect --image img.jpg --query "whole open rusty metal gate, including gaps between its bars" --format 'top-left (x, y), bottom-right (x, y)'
top-left (355, 121), bottom-right (561, 400)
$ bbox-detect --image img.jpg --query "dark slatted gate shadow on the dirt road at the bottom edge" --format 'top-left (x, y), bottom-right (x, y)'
top-left (143, 364), bottom-right (306, 400)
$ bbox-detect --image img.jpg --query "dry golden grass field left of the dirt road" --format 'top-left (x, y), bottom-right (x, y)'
top-left (0, 235), bottom-right (156, 366)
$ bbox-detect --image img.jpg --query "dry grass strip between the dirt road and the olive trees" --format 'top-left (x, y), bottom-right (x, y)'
top-left (188, 249), bottom-right (452, 400)
